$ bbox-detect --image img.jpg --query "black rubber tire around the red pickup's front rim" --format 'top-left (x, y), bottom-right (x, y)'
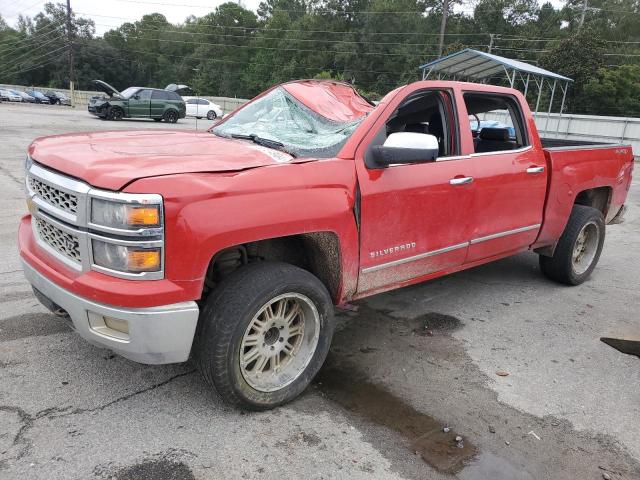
top-left (194, 262), bottom-right (334, 411)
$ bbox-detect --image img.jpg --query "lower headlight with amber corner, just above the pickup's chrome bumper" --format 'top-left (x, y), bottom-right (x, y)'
top-left (92, 239), bottom-right (162, 273)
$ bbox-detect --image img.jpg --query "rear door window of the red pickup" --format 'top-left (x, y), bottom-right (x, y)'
top-left (464, 92), bottom-right (529, 153)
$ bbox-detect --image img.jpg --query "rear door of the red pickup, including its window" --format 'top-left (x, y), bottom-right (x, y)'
top-left (463, 92), bottom-right (548, 263)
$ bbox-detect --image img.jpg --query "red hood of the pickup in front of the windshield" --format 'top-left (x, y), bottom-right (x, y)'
top-left (29, 130), bottom-right (298, 190)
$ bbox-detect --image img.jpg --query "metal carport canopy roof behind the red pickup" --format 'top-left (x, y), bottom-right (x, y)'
top-left (420, 48), bottom-right (573, 82)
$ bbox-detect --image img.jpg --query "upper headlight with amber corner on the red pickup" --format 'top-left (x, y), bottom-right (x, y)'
top-left (91, 198), bottom-right (162, 230)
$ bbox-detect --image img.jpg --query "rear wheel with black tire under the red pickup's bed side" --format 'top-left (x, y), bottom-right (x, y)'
top-left (540, 205), bottom-right (605, 285)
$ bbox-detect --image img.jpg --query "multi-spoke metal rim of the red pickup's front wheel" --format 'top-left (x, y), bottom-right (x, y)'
top-left (239, 293), bottom-right (320, 392)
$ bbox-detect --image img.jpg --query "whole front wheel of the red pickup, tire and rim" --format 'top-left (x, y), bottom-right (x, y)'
top-left (195, 262), bottom-right (334, 410)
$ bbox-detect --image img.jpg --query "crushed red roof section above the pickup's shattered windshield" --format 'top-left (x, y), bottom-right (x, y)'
top-left (282, 80), bottom-right (374, 122)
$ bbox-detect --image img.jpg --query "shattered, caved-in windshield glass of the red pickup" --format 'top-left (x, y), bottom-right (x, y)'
top-left (212, 88), bottom-right (364, 158)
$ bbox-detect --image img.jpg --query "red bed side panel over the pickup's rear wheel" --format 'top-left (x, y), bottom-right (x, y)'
top-left (534, 139), bottom-right (633, 247)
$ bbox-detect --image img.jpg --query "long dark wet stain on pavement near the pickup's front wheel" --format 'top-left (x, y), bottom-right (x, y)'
top-left (316, 366), bottom-right (476, 473)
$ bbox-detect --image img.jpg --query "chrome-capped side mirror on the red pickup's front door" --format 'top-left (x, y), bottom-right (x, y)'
top-left (372, 132), bottom-right (439, 167)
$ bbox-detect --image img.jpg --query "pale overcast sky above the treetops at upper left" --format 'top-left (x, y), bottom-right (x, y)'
top-left (0, 0), bottom-right (260, 35)
